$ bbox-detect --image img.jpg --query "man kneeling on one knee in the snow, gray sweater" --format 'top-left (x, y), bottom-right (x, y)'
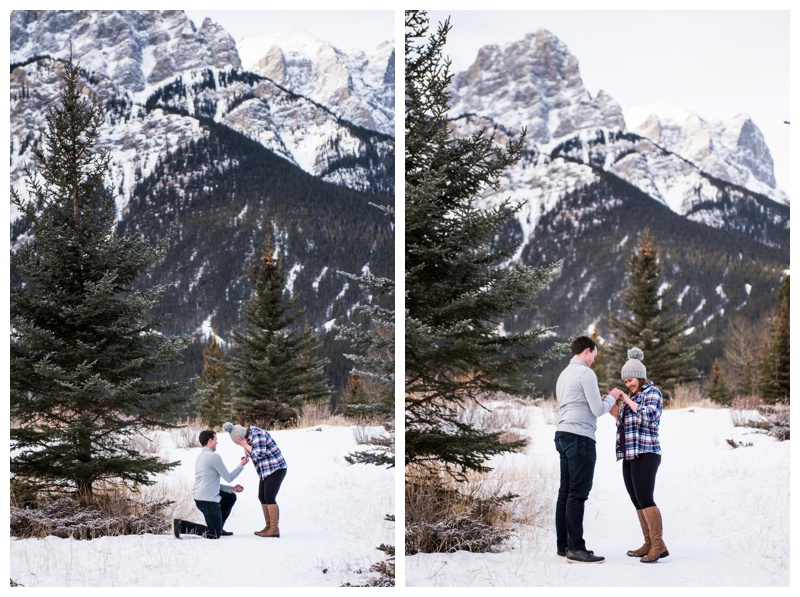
top-left (172, 429), bottom-right (249, 539)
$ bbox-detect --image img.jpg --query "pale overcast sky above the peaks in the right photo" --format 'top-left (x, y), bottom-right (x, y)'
top-left (428, 10), bottom-right (790, 193)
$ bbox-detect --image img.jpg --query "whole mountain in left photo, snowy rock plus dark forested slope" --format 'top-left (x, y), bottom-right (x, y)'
top-left (10, 10), bottom-right (394, 396)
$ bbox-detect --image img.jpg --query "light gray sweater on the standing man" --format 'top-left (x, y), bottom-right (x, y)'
top-left (556, 358), bottom-right (615, 439)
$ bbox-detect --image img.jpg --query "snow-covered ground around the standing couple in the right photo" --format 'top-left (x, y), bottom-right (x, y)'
top-left (405, 407), bottom-right (790, 587)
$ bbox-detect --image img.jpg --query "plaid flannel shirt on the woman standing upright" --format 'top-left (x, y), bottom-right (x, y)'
top-left (617, 382), bottom-right (664, 460)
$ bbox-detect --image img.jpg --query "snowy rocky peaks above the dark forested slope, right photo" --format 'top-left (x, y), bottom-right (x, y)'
top-left (450, 29), bottom-right (786, 235)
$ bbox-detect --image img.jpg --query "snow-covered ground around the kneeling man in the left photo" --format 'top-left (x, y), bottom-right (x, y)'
top-left (10, 425), bottom-right (394, 587)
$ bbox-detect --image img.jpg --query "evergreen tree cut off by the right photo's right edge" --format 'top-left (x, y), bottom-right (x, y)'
top-left (758, 276), bottom-right (790, 404)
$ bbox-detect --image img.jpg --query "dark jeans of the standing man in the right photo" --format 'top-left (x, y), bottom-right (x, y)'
top-left (555, 431), bottom-right (597, 551)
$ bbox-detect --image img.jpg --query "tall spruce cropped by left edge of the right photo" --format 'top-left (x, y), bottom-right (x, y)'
top-left (405, 11), bottom-right (562, 478)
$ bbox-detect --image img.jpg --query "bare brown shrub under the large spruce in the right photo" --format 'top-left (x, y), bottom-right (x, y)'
top-left (405, 472), bottom-right (515, 555)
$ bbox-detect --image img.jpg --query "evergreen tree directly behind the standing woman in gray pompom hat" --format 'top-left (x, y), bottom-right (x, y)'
top-left (608, 229), bottom-right (699, 398)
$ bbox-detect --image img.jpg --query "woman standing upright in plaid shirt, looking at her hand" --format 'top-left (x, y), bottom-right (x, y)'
top-left (611, 348), bottom-right (669, 563)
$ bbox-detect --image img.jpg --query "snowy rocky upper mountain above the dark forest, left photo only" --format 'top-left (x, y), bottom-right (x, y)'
top-left (11, 11), bottom-right (394, 214)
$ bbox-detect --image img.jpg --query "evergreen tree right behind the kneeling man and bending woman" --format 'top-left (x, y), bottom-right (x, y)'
top-left (228, 235), bottom-right (331, 429)
